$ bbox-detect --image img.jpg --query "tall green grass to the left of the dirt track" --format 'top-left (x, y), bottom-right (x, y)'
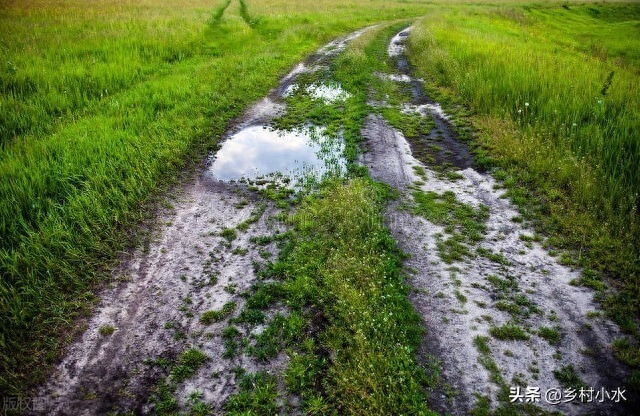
top-left (0, 0), bottom-right (436, 396)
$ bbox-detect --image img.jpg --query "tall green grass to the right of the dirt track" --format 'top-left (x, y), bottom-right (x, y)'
top-left (410, 4), bottom-right (640, 329)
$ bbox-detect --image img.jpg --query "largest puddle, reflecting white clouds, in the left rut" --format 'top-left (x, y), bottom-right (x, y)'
top-left (208, 125), bottom-right (346, 186)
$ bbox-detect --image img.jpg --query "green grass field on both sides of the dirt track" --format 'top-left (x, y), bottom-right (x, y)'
top-left (0, 0), bottom-right (640, 408)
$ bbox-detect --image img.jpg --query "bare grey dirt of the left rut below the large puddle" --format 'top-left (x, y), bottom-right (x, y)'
top-left (31, 178), bottom-right (288, 415)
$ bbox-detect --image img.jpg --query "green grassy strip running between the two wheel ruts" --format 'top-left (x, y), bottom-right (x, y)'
top-left (218, 26), bottom-right (437, 415)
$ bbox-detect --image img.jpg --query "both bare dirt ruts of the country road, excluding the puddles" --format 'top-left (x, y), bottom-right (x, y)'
top-left (33, 26), bottom-right (631, 415)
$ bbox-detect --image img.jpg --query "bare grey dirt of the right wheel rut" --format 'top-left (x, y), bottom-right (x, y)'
top-left (362, 26), bottom-right (635, 415)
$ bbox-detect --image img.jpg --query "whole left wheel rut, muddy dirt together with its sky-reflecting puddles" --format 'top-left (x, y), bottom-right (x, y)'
top-left (30, 31), bottom-right (370, 416)
